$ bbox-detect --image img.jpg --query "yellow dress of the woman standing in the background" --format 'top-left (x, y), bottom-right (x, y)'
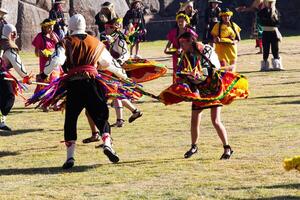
top-left (211, 23), bottom-right (241, 65)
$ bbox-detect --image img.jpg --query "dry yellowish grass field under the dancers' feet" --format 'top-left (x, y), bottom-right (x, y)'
top-left (0, 37), bottom-right (300, 200)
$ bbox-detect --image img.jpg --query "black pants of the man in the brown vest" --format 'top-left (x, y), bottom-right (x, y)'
top-left (64, 79), bottom-right (110, 141)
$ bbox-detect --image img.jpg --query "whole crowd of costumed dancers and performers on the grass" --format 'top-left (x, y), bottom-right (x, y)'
top-left (0, 0), bottom-right (292, 169)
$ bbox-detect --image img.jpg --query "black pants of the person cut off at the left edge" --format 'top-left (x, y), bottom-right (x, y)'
top-left (0, 74), bottom-right (15, 115)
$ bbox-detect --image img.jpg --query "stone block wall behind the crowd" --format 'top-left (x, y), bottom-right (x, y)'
top-left (0, 0), bottom-right (300, 49)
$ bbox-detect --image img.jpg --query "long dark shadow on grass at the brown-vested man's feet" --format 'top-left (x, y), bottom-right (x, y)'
top-left (0, 164), bottom-right (103, 176)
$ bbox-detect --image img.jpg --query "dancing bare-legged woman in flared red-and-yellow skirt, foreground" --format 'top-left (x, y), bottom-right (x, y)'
top-left (159, 33), bottom-right (248, 159)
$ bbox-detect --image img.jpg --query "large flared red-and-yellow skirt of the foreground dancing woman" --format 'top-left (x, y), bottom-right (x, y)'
top-left (159, 71), bottom-right (249, 108)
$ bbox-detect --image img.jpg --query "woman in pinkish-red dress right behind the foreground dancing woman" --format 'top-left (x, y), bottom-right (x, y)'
top-left (164, 12), bottom-right (198, 83)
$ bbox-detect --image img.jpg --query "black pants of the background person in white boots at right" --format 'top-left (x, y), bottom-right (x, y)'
top-left (262, 31), bottom-right (279, 60)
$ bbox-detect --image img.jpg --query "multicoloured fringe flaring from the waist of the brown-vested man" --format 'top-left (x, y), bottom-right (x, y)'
top-left (25, 74), bottom-right (143, 108)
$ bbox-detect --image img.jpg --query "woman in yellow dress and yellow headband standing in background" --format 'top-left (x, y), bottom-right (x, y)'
top-left (211, 9), bottom-right (241, 72)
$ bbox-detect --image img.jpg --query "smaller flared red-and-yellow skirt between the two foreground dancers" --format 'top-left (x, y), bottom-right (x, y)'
top-left (123, 59), bottom-right (167, 83)
